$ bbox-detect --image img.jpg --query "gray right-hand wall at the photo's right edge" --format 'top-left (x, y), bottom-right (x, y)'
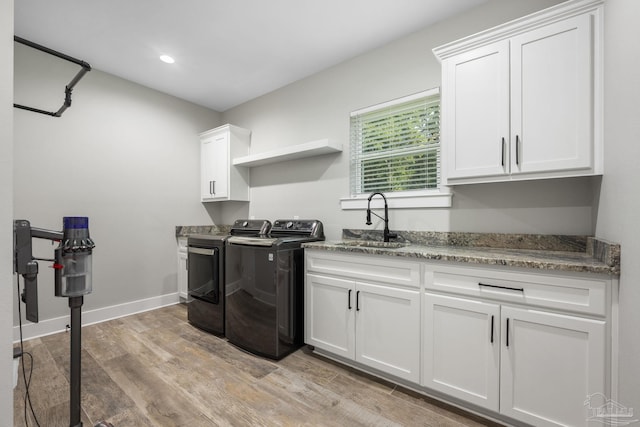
top-left (596, 0), bottom-right (640, 412)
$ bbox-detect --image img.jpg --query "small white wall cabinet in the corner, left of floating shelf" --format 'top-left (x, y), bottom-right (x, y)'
top-left (200, 125), bottom-right (251, 202)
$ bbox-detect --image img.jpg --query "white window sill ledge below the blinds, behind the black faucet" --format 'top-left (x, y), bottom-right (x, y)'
top-left (340, 186), bottom-right (453, 210)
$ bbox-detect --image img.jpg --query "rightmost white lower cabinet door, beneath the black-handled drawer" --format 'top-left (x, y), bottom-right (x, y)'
top-left (500, 306), bottom-right (608, 426)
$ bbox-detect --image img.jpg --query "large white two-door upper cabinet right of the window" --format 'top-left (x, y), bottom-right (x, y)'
top-left (434, 0), bottom-right (602, 185)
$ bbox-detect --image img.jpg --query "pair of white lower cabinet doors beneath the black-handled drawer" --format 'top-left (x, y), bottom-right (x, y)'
top-left (422, 293), bottom-right (606, 426)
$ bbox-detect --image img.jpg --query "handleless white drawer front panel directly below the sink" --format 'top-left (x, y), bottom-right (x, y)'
top-left (305, 249), bottom-right (420, 288)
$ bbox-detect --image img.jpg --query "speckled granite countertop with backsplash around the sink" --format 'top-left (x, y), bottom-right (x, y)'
top-left (304, 230), bottom-right (620, 276)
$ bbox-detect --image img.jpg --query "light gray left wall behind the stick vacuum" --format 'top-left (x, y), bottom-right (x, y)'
top-left (14, 44), bottom-right (220, 324)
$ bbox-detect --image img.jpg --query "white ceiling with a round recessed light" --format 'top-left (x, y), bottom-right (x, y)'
top-left (15, 0), bottom-right (487, 112)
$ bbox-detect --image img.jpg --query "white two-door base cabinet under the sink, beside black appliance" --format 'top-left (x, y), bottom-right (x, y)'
top-left (305, 251), bottom-right (420, 383)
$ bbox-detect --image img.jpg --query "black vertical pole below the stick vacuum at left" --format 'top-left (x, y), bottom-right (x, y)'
top-left (69, 296), bottom-right (83, 427)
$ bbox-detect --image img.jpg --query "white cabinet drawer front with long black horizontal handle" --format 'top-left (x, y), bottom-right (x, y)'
top-left (425, 267), bottom-right (610, 316)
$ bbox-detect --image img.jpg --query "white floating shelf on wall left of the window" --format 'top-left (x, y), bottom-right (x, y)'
top-left (233, 139), bottom-right (342, 167)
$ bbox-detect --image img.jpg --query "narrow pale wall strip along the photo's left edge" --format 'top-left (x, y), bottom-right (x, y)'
top-left (0, 0), bottom-right (13, 427)
